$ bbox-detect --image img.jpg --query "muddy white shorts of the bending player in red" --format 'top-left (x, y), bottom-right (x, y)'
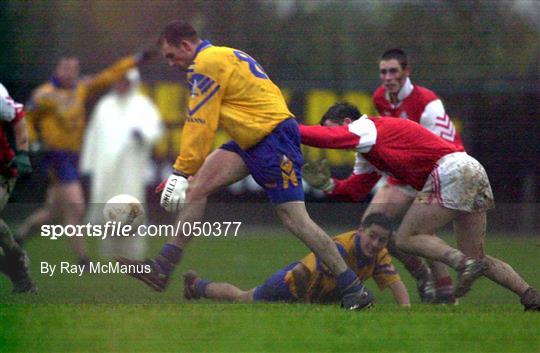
top-left (416, 152), bottom-right (495, 212)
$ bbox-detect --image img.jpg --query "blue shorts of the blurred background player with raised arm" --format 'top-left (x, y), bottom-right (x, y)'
top-left (40, 150), bottom-right (79, 184)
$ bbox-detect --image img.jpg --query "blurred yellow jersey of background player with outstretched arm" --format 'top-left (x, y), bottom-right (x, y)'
top-left (28, 56), bottom-right (136, 152)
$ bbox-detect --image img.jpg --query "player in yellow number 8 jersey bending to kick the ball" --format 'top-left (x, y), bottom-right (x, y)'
top-left (118, 21), bottom-right (372, 309)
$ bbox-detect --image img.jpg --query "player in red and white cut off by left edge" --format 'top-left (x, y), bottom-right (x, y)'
top-left (0, 84), bottom-right (37, 293)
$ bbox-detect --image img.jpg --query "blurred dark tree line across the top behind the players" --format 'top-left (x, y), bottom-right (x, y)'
top-left (0, 0), bottom-right (540, 94)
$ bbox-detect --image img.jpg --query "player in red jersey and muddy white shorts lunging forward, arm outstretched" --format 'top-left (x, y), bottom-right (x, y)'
top-left (300, 102), bottom-right (540, 310)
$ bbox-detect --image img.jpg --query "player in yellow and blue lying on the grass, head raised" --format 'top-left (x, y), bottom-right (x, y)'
top-left (184, 213), bottom-right (410, 306)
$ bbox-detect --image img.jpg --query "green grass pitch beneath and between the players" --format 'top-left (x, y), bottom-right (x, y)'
top-left (0, 232), bottom-right (540, 353)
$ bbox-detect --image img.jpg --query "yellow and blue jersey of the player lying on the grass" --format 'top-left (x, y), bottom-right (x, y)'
top-left (285, 231), bottom-right (401, 303)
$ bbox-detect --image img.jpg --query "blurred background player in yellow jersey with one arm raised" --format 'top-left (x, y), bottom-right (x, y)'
top-left (17, 52), bottom-right (150, 263)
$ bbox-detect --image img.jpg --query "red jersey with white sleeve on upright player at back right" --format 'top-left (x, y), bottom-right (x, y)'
top-left (373, 78), bottom-right (465, 151)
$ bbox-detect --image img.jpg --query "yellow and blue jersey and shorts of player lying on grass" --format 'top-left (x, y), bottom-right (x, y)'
top-left (254, 231), bottom-right (401, 303)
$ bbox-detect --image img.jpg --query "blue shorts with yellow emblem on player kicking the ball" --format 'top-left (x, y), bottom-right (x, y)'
top-left (220, 118), bottom-right (304, 204)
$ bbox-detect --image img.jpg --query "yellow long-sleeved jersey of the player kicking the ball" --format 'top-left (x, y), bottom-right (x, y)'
top-left (174, 40), bottom-right (293, 175)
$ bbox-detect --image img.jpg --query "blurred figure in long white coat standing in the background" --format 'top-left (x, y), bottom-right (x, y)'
top-left (80, 69), bottom-right (163, 258)
